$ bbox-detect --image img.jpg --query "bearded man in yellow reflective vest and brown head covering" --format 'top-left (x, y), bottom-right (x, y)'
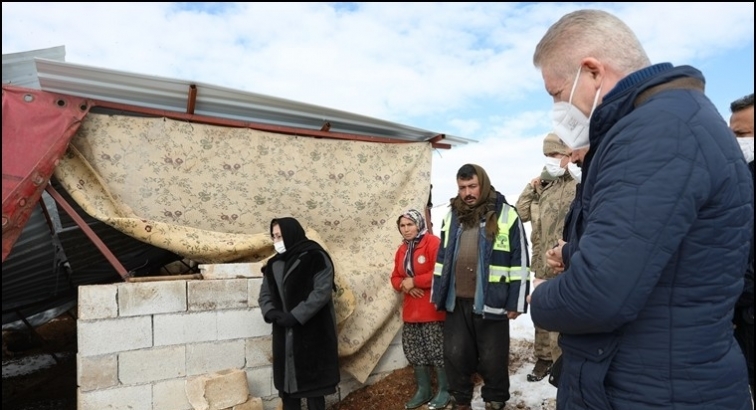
top-left (431, 164), bottom-right (528, 410)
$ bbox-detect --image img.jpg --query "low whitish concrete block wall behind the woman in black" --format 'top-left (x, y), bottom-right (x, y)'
top-left (77, 278), bottom-right (407, 410)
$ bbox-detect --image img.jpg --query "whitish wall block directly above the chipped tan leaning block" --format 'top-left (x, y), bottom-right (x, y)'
top-left (186, 340), bottom-right (245, 376)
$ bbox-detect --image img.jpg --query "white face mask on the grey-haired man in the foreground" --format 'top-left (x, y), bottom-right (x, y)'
top-left (551, 66), bottom-right (603, 149)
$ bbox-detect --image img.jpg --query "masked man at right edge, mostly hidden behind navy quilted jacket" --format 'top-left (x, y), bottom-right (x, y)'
top-left (730, 93), bottom-right (753, 396)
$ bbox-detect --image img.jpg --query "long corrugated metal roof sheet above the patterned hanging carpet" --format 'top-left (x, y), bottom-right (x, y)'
top-left (35, 58), bottom-right (475, 145)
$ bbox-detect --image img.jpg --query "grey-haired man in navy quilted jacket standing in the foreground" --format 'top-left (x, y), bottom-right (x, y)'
top-left (531, 10), bottom-right (753, 410)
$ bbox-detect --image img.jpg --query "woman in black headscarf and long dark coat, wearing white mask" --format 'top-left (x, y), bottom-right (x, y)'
top-left (258, 218), bottom-right (340, 410)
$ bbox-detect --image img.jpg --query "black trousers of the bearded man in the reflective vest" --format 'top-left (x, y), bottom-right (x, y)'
top-left (444, 298), bottom-right (509, 405)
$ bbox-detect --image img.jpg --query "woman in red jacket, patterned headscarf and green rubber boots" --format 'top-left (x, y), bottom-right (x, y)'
top-left (391, 209), bottom-right (450, 409)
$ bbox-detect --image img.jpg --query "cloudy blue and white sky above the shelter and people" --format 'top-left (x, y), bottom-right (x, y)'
top-left (2, 2), bottom-right (754, 227)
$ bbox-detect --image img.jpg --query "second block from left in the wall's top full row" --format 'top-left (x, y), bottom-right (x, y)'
top-left (118, 280), bottom-right (186, 316)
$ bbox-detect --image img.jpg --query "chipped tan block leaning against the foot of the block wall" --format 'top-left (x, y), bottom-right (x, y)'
top-left (186, 369), bottom-right (249, 410)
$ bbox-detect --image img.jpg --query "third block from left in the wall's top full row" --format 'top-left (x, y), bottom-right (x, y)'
top-left (186, 279), bottom-right (248, 311)
